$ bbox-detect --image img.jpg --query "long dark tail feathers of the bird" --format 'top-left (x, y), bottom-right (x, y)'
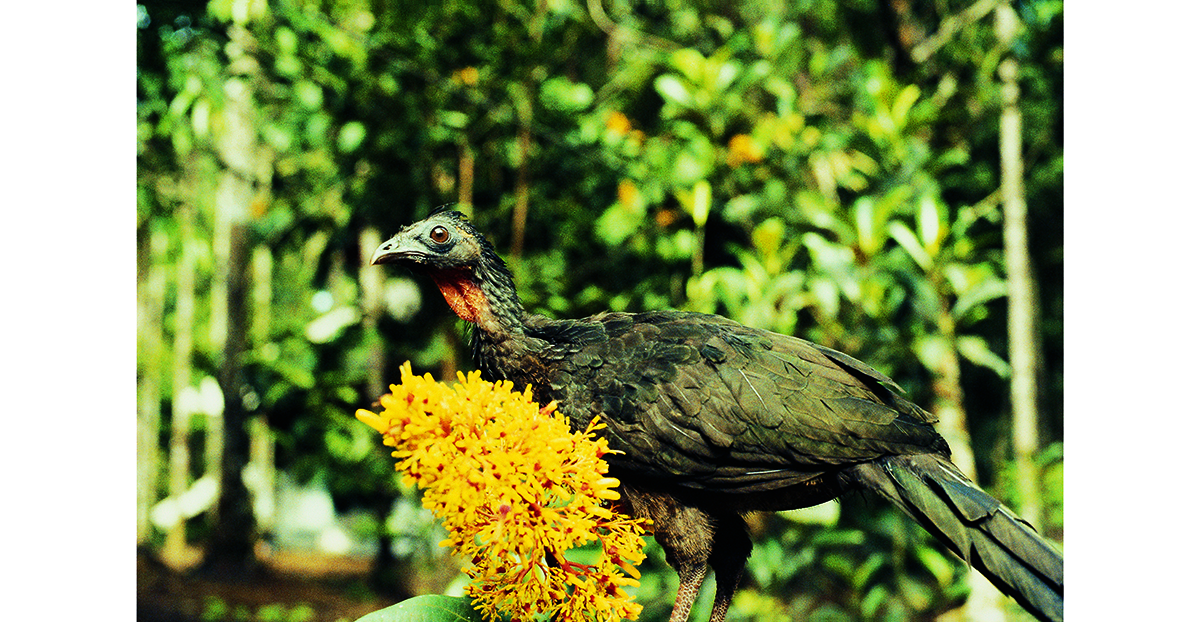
top-left (854, 454), bottom-right (1062, 622)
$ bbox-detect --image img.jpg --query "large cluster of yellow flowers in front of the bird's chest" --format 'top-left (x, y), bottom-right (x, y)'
top-left (356, 363), bottom-right (646, 621)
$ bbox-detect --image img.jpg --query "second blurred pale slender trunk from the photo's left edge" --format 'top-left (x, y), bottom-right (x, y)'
top-left (162, 199), bottom-right (196, 568)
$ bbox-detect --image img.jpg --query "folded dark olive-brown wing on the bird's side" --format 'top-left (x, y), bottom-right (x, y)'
top-left (542, 312), bottom-right (944, 491)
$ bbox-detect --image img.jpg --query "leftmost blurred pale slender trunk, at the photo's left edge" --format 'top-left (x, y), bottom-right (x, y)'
top-left (138, 226), bottom-right (168, 545)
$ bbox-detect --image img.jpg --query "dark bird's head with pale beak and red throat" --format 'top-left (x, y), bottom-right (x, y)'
top-left (371, 211), bottom-right (523, 331)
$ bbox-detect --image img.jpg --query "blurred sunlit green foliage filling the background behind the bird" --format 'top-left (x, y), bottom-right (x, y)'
top-left (137, 0), bottom-right (1063, 620)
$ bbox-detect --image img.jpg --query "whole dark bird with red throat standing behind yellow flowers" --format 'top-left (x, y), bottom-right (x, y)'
top-left (371, 210), bottom-right (1063, 622)
